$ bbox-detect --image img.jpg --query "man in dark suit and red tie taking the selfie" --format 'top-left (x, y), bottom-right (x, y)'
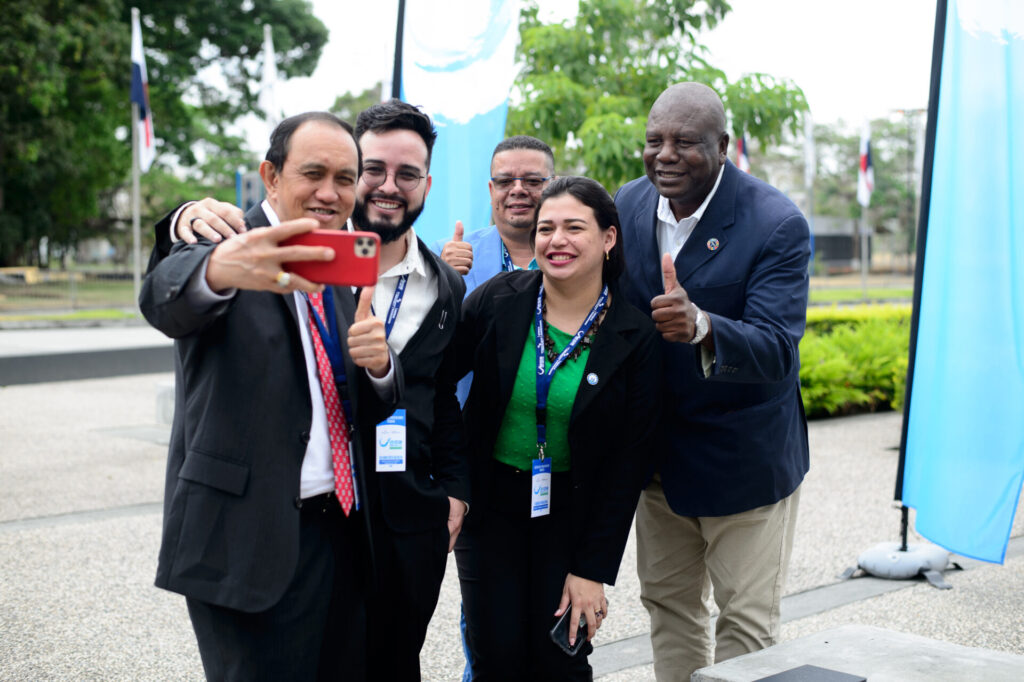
top-left (139, 114), bottom-right (401, 680)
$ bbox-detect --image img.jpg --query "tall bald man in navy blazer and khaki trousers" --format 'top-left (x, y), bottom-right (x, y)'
top-left (615, 83), bottom-right (810, 680)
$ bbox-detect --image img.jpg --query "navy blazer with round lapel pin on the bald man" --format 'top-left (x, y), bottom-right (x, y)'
top-left (615, 161), bottom-right (810, 516)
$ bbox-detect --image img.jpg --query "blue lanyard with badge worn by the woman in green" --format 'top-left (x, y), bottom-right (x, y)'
top-left (529, 283), bottom-right (608, 518)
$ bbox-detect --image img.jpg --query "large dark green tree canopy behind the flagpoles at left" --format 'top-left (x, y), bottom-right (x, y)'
top-left (0, 0), bottom-right (328, 264)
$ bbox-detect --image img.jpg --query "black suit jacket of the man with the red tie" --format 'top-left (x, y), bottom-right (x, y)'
top-left (139, 202), bottom-right (402, 611)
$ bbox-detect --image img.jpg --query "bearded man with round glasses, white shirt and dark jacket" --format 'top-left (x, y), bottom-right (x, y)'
top-left (154, 99), bottom-right (469, 680)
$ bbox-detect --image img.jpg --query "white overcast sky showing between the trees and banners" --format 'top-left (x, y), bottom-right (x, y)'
top-left (243, 0), bottom-right (936, 150)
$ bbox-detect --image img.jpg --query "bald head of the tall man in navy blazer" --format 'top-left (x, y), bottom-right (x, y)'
top-left (643, 83), bottom-right (729, 219)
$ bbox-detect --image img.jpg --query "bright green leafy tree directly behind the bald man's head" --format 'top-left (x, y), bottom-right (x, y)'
top-left (507, 0), bottom-right (807, 189)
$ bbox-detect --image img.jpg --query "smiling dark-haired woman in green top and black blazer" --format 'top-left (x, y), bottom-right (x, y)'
top-left (456, 177), bottom-right (660, 680)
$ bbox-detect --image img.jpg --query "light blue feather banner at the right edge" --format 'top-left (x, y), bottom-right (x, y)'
top-left (903, 0), bottom-right (1024, 563)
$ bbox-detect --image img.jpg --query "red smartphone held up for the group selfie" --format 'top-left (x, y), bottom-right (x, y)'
top-left (281, 229), bottom-right (381, 287)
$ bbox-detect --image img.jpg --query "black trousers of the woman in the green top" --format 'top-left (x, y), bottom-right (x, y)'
top-left (456, 463), bottom-right (593, 681)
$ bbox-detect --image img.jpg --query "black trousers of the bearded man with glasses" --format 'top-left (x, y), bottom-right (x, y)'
top-left (367, 512), bottom-right (449, 682)
